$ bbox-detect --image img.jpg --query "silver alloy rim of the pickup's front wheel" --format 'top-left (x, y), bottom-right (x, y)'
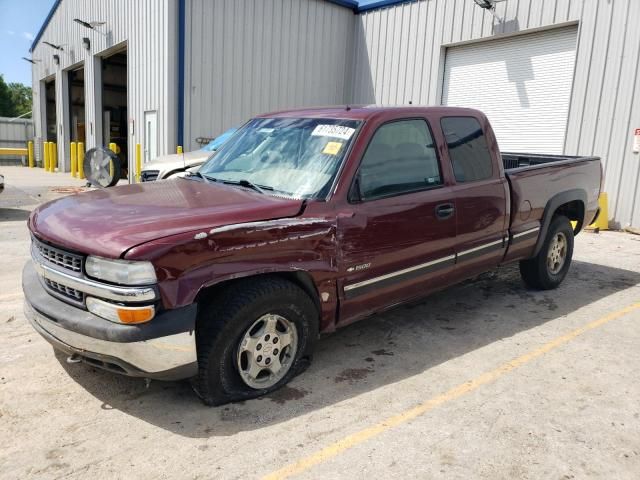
top-left (236, 313), bottom-right (298, 389)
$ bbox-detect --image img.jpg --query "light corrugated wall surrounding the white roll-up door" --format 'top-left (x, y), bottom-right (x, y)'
top-left (350, 0), bottom-right (640, 226)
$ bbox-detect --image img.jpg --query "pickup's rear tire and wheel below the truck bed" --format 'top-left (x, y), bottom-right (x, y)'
top-left (520, 215), bottom-right (573, 290)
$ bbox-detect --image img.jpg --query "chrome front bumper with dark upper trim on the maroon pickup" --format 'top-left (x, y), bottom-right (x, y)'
top-left (22, 261), bottom-right (198, 380)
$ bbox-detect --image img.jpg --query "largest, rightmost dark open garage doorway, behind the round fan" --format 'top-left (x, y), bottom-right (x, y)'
top-left (101, 48), bottom-right (129, 178)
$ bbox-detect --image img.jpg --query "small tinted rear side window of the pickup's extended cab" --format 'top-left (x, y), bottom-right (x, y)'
top-left (440, 117), bottom-right (493, 182)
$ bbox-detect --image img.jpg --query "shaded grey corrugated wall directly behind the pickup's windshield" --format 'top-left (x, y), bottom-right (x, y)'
top-left (184, 0), bottom-right (354, 149)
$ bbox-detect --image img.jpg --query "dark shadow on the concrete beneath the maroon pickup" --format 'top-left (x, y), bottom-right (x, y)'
top-left (59, 262), bottom-right (640, 438)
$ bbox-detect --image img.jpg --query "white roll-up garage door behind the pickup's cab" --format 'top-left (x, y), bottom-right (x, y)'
top-left (442, 26), bottom-right (578, 154)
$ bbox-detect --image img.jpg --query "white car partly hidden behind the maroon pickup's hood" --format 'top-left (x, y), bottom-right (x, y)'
top-left (140, 128), bottom-right (237, 182)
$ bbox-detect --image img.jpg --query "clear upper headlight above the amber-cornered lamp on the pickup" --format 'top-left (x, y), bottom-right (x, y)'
top-left (84, 256), bottom-right (157, 285)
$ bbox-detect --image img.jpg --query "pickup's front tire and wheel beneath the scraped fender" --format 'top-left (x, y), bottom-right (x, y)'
top-left (193, 276), bottom-right (318, 405)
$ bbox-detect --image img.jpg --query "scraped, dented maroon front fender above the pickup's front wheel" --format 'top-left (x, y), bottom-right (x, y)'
top-left (125, 218), bottom-right (337, 308)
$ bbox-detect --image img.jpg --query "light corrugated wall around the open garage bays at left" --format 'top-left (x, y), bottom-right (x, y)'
top-left (32, 0), bottom-right (178, 176)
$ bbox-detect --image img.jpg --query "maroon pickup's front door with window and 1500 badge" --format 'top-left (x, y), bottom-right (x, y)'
top-left (338, 118), bottom-right (456, 323)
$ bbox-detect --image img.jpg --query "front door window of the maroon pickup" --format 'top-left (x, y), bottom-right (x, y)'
top-left (359, 120), bottom-right (442, 200)
